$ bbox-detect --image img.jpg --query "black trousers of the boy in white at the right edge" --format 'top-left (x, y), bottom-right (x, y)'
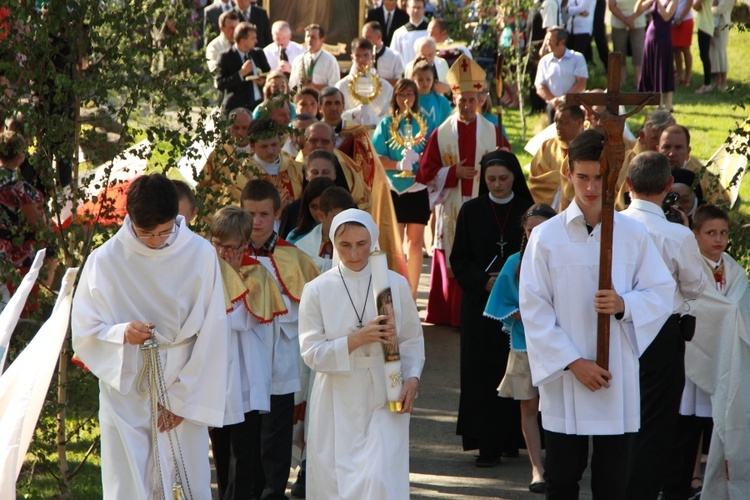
top-left (662, 415), bottom-right (711, 500)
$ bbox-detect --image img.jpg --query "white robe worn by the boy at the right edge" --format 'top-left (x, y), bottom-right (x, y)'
top-left (685, 253), bottom-right (750, 499)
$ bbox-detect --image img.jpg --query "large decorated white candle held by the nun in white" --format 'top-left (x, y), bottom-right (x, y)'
top-left (370, 251), bottom-right (404, 412)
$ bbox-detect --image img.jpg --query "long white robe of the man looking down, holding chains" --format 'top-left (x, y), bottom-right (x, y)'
top-left (72, 216), bottom-right (229, 500)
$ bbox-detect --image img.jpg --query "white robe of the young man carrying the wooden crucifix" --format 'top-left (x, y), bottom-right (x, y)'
top-left (520, 201), bottom-right (675, 435)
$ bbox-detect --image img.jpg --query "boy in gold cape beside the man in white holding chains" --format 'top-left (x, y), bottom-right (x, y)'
top-left (209, 206), bottom-right (287, 498)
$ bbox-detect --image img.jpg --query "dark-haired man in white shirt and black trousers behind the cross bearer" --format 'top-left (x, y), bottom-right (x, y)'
top-left (622, 151), bottom-right (706, 499)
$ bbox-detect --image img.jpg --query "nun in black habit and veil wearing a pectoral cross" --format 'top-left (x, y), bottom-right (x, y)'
top-left (450, 151), bottom-right (534, 467)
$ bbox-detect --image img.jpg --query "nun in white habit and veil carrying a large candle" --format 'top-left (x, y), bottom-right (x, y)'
top-left (299, 209), bottom-right (424, 500)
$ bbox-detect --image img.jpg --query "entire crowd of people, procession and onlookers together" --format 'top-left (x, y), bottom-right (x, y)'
top-left (0, 0), bottom-right (750, 499)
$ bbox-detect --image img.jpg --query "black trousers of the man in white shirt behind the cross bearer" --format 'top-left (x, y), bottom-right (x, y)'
top-left (627, 314), bottom-right (697, 500)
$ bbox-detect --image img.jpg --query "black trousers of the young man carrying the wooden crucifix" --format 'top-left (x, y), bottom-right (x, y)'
top-left (544, 431), bottom-right (634, 500)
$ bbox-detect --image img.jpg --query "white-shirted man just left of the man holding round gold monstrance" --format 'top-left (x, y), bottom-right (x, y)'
top-left (289, 24), bottom-right (341, 90)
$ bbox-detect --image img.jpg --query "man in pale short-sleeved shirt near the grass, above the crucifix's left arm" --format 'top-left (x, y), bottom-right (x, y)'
top-left (534, 26), bottom-right (589, 122)
